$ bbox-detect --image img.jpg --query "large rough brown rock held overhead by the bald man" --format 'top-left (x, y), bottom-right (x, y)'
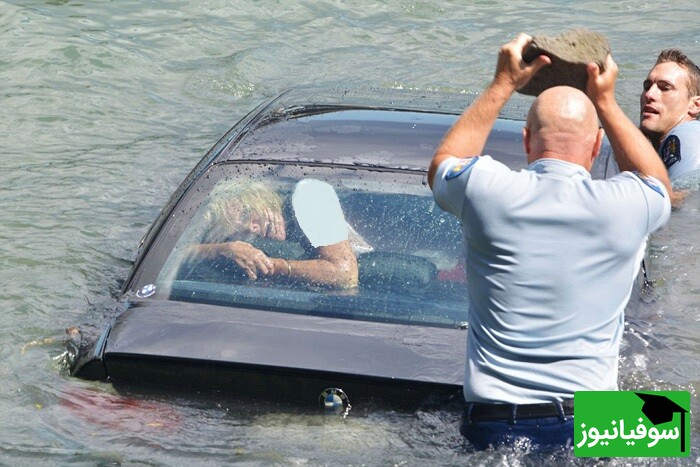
top-left (519, 29), bottom-right (610, 96)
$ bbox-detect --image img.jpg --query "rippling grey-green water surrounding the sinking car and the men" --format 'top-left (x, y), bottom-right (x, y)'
top-left (0, 0), bottom-right (700, 465)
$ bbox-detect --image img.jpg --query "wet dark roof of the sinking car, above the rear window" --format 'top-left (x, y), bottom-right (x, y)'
top-left (210, 89), bottom-right (525, 171)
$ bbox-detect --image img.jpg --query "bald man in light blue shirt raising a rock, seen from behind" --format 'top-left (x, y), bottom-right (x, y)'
top-left (428, 35), bottom-right (671, 449)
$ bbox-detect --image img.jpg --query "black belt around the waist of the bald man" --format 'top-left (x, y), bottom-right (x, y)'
top-left (464, 399), bottom-right (574, 422)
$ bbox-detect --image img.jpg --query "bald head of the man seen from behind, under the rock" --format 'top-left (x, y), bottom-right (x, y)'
top-left (524, 86), bottom-right (602, 170)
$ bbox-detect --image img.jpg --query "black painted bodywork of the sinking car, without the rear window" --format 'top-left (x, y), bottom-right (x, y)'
top-left (72, 88), bottom-right (616, 410)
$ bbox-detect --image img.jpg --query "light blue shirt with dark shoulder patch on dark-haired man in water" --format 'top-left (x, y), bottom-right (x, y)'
top-left (659, 120), bottom-right (700, 181)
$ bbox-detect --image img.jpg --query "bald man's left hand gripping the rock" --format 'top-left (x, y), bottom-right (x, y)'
top-left (493, 33), bottom-right (552, 91)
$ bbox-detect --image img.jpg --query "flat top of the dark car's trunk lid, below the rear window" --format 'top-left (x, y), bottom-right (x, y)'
top-left (103, 301), bottom-right (466, 386)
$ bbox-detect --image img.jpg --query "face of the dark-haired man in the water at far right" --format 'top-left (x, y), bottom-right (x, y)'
top-left (639, 62), bottom-right (694, 142)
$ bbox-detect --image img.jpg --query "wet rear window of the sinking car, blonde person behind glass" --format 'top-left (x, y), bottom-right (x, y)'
top-left (150, 162), bottom-right (468, 327)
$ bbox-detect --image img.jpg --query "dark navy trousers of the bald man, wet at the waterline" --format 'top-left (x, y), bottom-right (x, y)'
top-left (459, 402), bottom-right (574, 450)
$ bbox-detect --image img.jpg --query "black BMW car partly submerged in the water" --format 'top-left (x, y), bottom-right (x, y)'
top-left (71, 91), bottom-right (609, 406)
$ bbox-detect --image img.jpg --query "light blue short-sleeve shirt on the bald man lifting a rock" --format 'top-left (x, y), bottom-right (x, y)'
top-left (433, 156), bottom-right (670, 404)
